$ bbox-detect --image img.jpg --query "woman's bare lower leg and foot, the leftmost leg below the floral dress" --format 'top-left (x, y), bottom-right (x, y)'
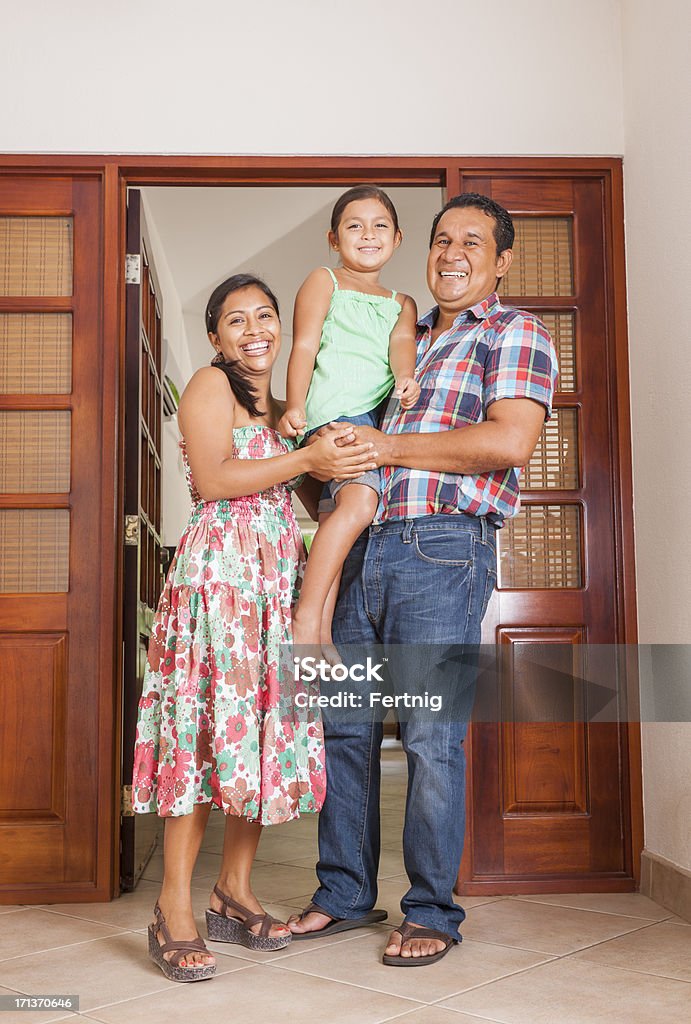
top-left (159, 804), bottom-right (216, 967)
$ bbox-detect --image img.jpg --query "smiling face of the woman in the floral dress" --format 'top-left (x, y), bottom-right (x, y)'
top-left (209, 285), bottom-right (280, 374)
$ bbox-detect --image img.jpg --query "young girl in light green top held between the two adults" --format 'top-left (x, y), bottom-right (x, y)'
top-left (278, 184), bottom-right (420, 660)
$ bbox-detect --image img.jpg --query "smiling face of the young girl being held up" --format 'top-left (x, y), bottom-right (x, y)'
top-left (329, 199), bottom-right (401, 271)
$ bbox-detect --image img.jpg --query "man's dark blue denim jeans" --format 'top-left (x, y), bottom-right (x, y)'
top-left (314, 514), bottom-right (496, 941)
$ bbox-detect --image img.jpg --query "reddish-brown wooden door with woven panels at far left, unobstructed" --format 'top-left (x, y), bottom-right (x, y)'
top-left (0, 172), bottom-right (113, 903)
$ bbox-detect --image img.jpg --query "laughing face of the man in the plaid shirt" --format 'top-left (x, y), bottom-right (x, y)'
top-left (427, 206), bottom-right (513, 316)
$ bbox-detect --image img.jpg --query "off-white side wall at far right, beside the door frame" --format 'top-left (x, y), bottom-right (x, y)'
top-left (622, 0), bottom-right (691, 870)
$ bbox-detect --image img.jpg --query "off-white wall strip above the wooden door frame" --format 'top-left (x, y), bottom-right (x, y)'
top-left (0, 0), bottom-right (623, 155)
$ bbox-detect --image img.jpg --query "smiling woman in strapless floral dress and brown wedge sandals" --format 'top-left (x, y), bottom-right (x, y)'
top-left (133, 274), bottom-right (374, 981)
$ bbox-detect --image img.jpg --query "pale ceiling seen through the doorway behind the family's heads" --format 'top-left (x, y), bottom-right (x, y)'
top-left (142, 185), bottom-right (442, 379)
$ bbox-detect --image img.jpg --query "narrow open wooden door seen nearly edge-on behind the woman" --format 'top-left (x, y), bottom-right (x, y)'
top-left (120, 188), bottom-right (163, 891)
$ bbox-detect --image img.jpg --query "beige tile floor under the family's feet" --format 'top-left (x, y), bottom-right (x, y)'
top-left (0, 750), bottom-right (691, 1024)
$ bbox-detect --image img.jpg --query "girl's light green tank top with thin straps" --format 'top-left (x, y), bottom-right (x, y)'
top-left (305, 266), bottom-right (401, 430)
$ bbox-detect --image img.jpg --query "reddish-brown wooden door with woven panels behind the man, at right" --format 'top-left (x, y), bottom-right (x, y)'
top-left (459, 171), bottom-right (634, 893)
